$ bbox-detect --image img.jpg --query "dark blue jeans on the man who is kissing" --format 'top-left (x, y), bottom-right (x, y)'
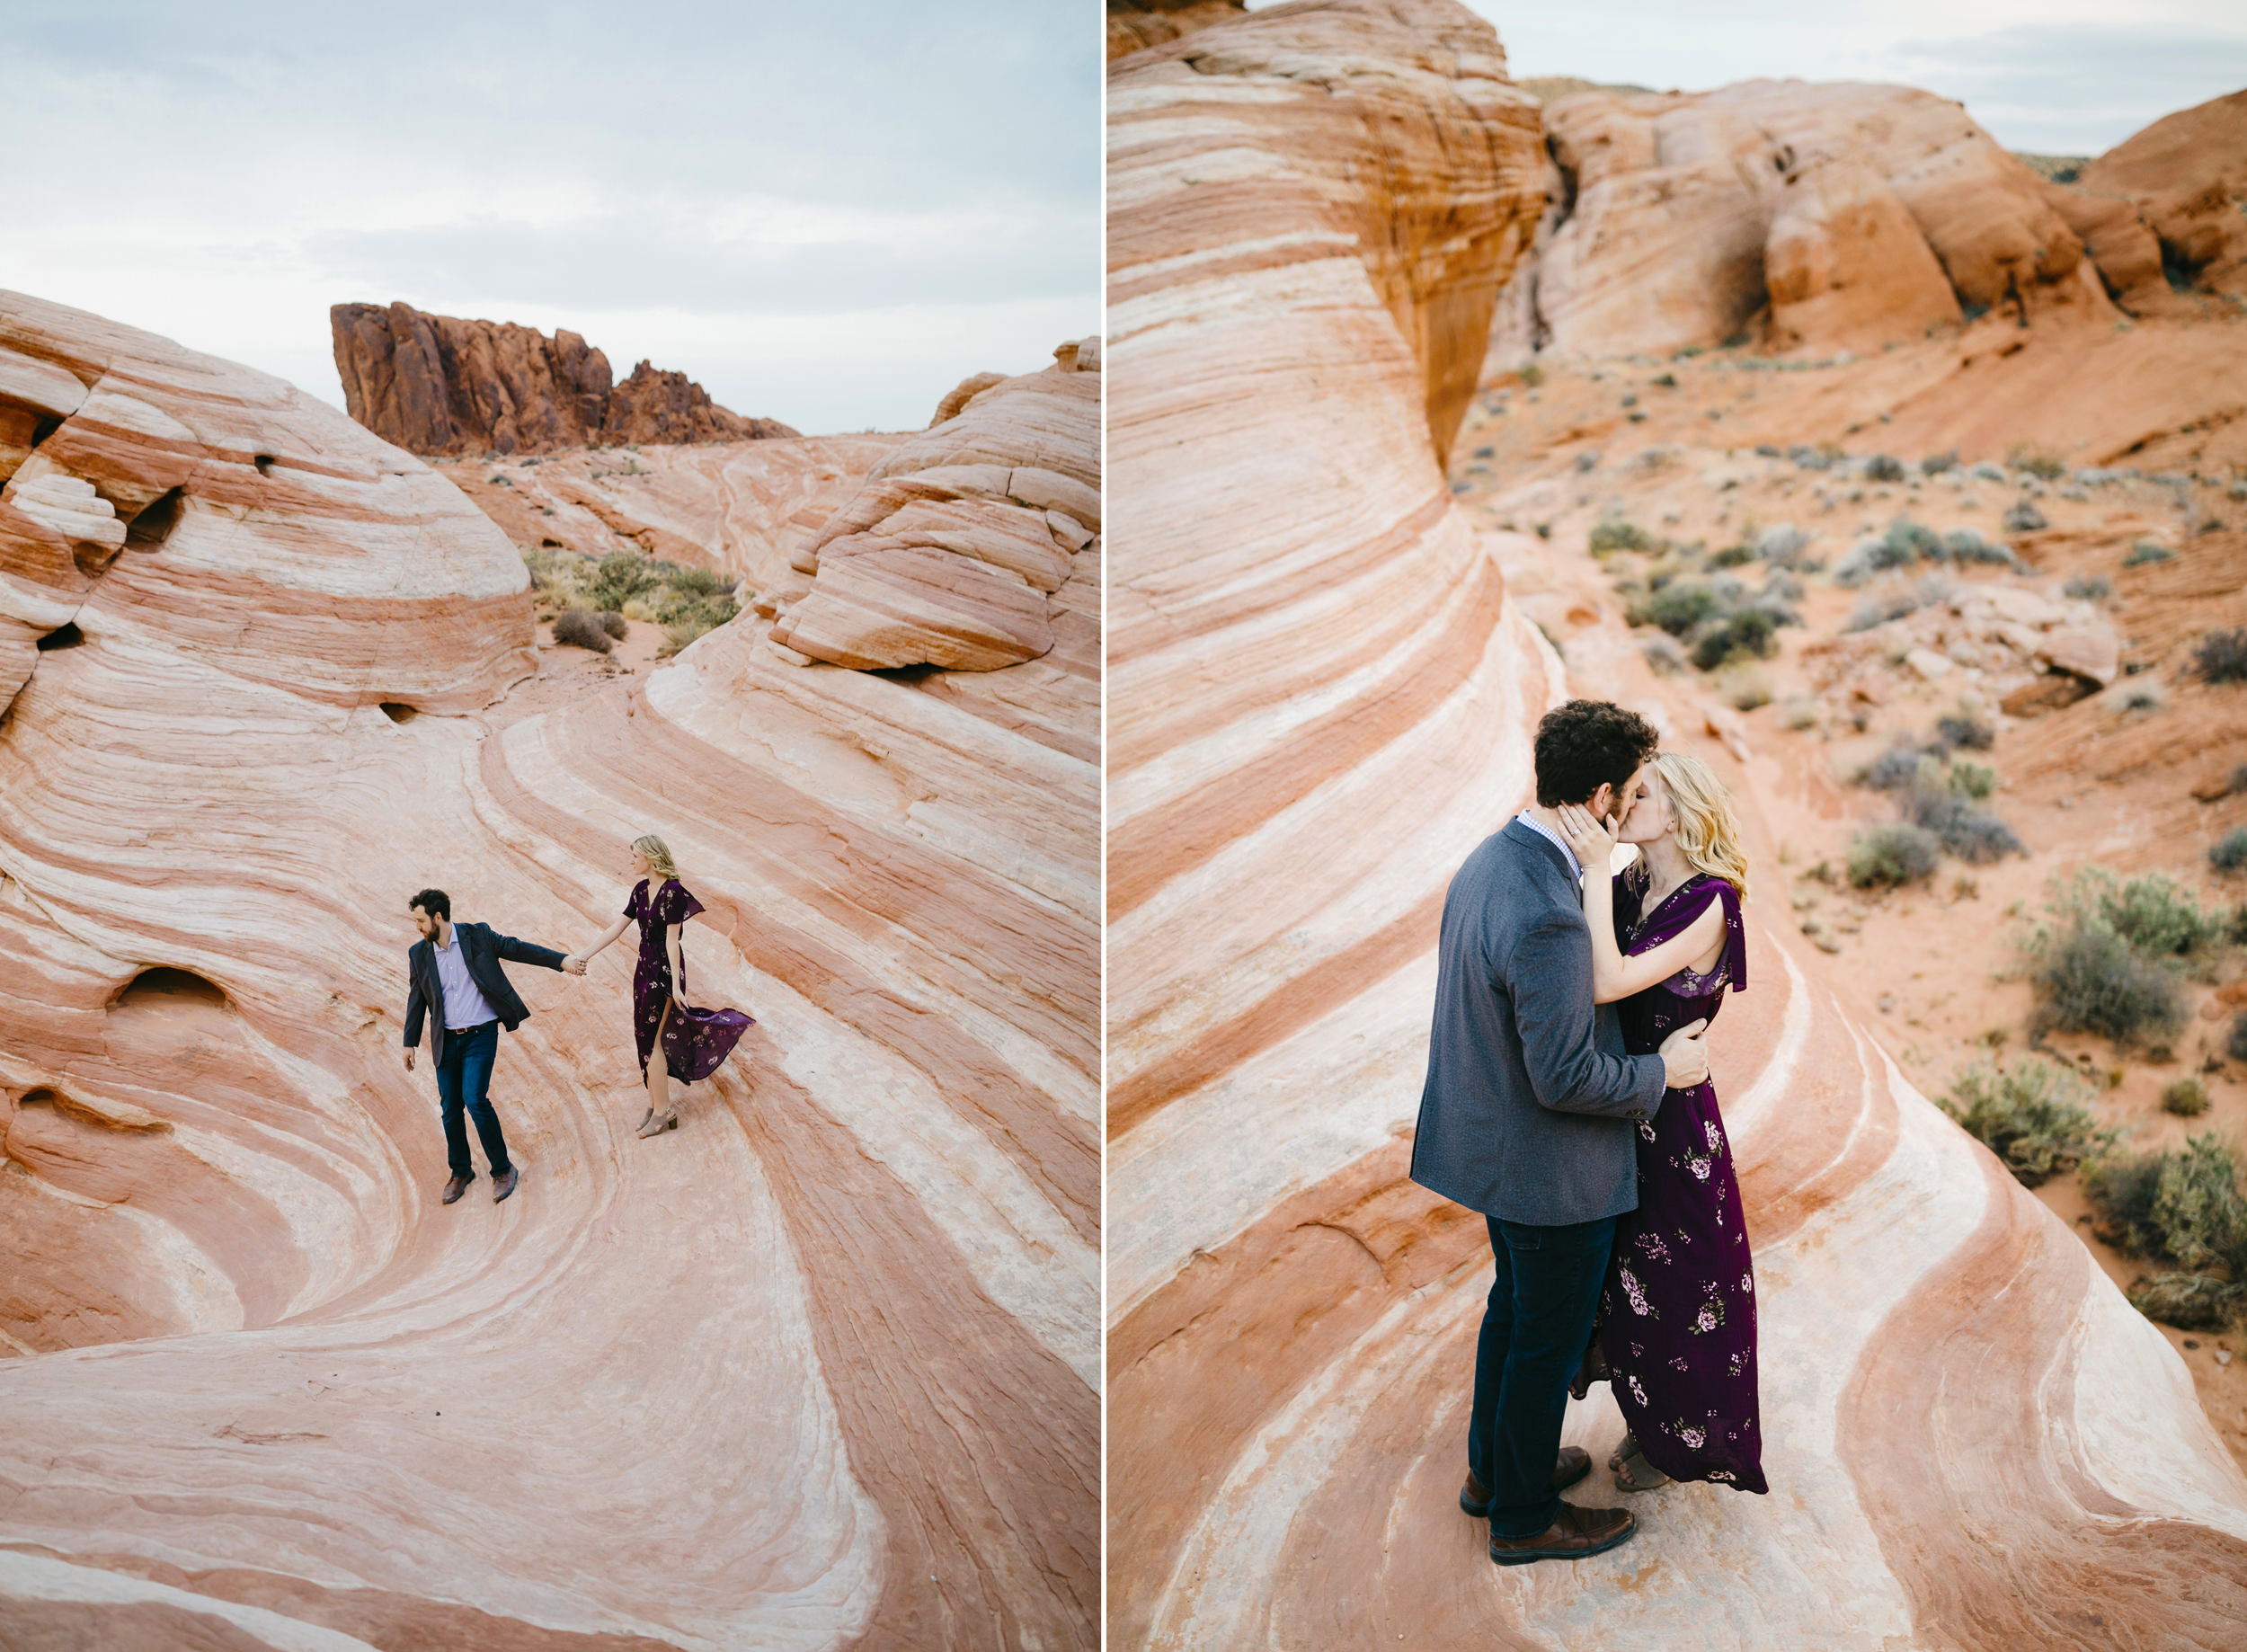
top-left (1468, 1216), bottom-right (1616, 1537)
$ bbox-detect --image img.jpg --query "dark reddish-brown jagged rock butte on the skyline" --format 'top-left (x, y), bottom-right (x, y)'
top-left (328, 304), bottom-right (798, 457)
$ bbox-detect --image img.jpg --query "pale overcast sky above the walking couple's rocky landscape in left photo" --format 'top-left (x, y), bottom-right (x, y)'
top-left (0, 0), bottom-right (1101, 431)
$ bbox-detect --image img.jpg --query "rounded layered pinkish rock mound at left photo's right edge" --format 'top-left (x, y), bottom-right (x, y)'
top-left (759, 337), bottom-right (1101, 672)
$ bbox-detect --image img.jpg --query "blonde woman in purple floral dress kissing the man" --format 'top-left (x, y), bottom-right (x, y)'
top-left (1562, 753), bottom-right (1769, 1492)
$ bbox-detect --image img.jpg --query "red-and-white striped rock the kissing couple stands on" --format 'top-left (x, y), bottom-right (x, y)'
top-left (1108, 0), bottom-right (2247, 1648)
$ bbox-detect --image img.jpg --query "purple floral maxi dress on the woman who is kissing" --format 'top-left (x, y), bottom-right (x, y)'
top-left (1600, 863), bottom-right (1769, 1492)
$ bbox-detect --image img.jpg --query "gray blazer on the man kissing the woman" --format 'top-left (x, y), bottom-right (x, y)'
top-left (1411, 821), bottom-right (1665, 1227)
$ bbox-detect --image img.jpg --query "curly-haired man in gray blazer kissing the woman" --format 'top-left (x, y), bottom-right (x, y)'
top-left (1411, 699), bottom-right (1708, 1567)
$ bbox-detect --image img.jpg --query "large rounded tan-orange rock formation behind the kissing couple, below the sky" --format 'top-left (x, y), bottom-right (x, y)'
top-left (1492, 81), bottom-right (2112, 364)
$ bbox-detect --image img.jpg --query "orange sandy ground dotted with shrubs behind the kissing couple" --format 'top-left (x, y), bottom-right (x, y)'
top-left (1452, 319), bottom-right (2247, 1468)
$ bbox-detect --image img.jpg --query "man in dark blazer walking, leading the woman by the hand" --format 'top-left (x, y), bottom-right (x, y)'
top-left (407, 890), bottom-right (584, 1204)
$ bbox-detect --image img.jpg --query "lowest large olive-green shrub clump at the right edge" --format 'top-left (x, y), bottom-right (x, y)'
top-left (2083, 1132), bottom-right (2247, 1330)
